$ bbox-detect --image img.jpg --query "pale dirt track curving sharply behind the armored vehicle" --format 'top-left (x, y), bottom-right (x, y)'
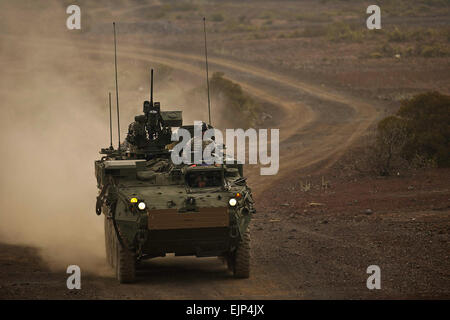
top-left (10, 34), bottom-right (378, 191)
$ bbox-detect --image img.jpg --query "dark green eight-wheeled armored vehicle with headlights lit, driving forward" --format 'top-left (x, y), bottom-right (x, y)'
top-left (95, 69), bottom-right (255, 283)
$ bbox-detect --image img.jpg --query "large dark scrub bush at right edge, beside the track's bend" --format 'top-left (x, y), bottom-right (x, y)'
top-left (349, 92), bottom-right (450, 176)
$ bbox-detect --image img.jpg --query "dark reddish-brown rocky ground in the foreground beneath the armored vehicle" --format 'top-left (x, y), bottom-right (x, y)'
top-left (0, 170), bottom-right (450, 299)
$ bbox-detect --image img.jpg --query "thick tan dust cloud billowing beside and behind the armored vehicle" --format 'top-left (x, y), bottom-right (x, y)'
top-left (0, 0), bottom-right (229, 274)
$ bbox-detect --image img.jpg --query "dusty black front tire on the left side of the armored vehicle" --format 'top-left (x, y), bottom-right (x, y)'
top-left (114, 232), bottom-right (136, 283)
